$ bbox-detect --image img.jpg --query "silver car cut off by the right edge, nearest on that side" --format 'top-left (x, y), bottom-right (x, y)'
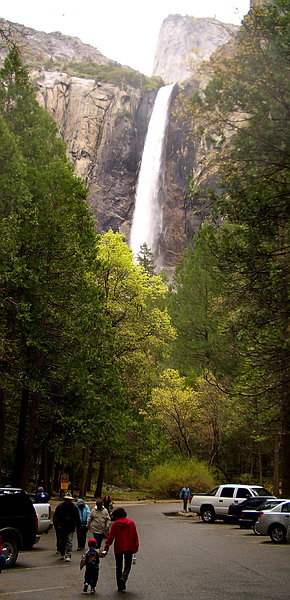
top-left (254, 500), bottom-right (290, 544)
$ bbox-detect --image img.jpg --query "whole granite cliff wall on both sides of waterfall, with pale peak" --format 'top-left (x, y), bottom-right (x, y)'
top-left (0, 15), bottom-right (239, 275)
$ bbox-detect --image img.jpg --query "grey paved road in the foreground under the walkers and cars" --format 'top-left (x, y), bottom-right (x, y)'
top-left (0, 503), bottom-right (290, 600)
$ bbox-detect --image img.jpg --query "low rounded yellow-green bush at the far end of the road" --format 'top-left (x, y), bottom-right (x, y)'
top-left (140, 458), bottom-right (215, 498)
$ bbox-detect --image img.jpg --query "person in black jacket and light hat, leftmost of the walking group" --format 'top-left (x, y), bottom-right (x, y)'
top-left (53, 494), bottom-right (80, 562)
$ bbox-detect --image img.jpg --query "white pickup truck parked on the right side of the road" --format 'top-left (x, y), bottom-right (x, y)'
top-left (188, 483), bottom-right (271, 523)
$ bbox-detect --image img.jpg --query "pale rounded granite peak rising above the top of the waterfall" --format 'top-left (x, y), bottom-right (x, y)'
top-left (153, 15), bottom-right (238, 83)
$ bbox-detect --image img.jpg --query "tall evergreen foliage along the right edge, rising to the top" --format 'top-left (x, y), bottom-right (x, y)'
top-left (174, 0), bottom-right (290, 493)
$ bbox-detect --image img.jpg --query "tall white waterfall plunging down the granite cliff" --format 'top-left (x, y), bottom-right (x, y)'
top-left (130, 83), bottom-right (175, 267)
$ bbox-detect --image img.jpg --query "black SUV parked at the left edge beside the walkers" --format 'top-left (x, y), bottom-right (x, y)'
top-left (0, 488), bottom-right (38, 567)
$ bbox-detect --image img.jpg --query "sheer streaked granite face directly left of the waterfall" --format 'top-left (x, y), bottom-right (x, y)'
top-left (33, 71), bottom-right (156, 238)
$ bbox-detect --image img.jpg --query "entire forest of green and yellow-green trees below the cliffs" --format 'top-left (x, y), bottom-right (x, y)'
top-left (0, 0), bottom-right (290, 495)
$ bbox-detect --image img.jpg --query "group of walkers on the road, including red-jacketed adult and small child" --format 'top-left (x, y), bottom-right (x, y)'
top-left (53, 493), bottom-right (139, 594)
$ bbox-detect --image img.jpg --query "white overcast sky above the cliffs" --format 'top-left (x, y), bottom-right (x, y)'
top-left (0, 0), bottom-right (250, 75)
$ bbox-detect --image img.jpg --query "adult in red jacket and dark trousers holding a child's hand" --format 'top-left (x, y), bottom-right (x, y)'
top-left (104, 507), bottom-right (139, 592)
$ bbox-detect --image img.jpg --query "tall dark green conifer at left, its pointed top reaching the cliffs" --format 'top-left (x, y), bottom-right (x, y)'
top-left (0, 47), bottom-right (105, 486)
